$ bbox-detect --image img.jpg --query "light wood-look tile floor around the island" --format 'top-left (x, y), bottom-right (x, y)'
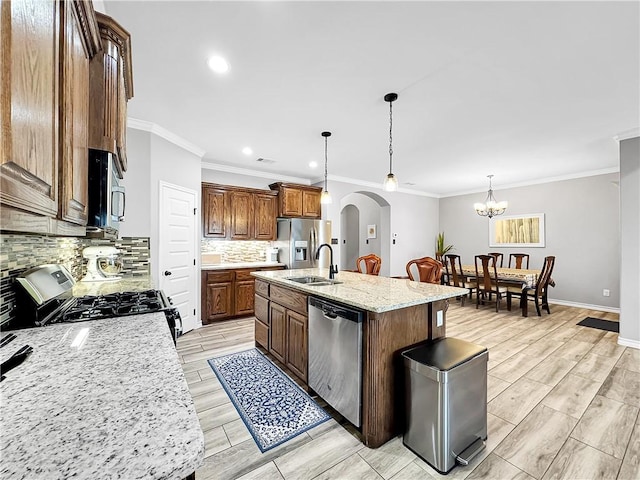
top-left (178, 302), bottom-right (640, 480)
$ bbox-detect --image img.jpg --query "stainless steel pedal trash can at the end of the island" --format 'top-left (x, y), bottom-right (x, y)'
top-left (402, 338), bottom-right (489, 474)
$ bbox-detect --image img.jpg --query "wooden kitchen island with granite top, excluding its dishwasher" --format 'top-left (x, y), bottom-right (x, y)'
top-left (253, 269), bottom-right (468, 448)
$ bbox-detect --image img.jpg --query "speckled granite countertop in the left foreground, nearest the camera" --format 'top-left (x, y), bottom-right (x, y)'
top-left (0, 312), bottom-right (204, 480)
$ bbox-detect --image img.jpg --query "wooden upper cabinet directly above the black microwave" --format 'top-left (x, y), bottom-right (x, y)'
top-left (89, 13), bottom-right (133, 178)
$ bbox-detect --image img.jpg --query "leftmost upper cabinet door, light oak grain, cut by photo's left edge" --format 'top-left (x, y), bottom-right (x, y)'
top-left (0, 0), bottom-right (59, 218)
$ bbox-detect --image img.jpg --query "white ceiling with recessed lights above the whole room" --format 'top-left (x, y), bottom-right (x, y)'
top-left (104, 0), bottom-right (640, 196)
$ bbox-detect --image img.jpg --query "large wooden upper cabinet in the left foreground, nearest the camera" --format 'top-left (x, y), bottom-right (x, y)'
top-left (0, 0), bottom-right (100, 235)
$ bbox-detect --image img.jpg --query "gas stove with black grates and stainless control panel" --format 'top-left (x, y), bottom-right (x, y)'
top-left (11, 265), bottom-right (182, 343)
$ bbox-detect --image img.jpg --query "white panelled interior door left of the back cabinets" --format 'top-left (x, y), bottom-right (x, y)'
top-left (158, 182), bottom-right (200, 332)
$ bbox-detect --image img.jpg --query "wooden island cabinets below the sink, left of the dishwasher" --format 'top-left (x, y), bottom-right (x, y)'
top-left (255, 279), bottom-right (309, 383)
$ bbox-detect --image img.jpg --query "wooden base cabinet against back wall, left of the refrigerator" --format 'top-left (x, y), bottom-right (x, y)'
top-left (201, 267), bottom-right (284, 322)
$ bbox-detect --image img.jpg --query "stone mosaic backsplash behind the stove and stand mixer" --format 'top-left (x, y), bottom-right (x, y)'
top-left (0, 234), bottom-right (150, 325)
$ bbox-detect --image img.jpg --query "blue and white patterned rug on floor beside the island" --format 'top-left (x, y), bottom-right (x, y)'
top-left (209, 349), bottom-right (331, 452)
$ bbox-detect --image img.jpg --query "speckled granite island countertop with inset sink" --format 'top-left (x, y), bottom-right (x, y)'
top-left (252, 268), bottom-right (469, 313)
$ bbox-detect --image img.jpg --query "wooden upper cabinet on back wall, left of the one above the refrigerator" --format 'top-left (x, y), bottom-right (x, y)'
top-left (202, 183), bottom-right (278, 240)
